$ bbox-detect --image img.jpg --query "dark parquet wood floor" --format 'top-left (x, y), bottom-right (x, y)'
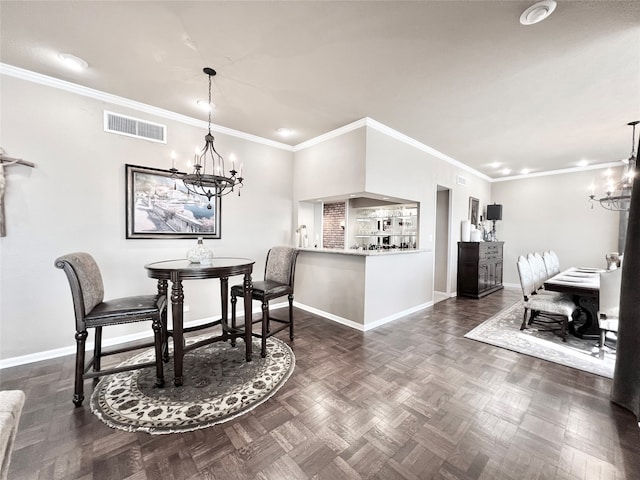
top-left (0, 290), bottom-right (640, 480)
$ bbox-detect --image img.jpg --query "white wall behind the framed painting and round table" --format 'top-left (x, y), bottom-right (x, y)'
top-left (0, 76), bottom-right (294, 360)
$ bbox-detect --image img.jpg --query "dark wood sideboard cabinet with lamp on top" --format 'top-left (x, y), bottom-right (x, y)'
top-left (458, 242), bottom-right (504, 298)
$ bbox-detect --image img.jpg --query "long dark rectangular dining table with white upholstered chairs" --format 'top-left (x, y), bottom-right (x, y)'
top-left (544, 267), bottom-right (604, 339)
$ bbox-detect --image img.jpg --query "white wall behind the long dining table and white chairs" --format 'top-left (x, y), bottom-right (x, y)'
top-left (492, 170), bottom-right (620, 285)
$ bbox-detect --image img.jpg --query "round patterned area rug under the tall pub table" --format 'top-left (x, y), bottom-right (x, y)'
top-left (91, 337), bottom-right (295, 434)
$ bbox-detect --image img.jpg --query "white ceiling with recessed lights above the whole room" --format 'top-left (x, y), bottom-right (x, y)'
top-left (0, 0), bottom-right (640, 178)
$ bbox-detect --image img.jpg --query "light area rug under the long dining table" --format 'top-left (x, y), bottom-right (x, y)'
top-left (465, 302), bottom-right (616, 378)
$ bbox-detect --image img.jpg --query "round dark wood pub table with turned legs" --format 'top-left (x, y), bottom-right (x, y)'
top-left (144, 257), bottom-right (255, 386)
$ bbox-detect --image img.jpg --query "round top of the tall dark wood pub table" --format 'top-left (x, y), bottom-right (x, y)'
top-left (144, 257), bottom-right (255, 279)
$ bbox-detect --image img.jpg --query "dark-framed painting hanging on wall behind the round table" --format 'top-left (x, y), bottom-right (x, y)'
top-left (125, 165), bottom-right (220, 238)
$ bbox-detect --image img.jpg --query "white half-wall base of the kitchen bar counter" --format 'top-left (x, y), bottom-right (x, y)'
top-left (295, 248), bottom-right (433, 331)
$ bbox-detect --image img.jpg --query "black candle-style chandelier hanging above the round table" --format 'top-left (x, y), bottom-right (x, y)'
top-left (170, 67), bottom-right (244, 209)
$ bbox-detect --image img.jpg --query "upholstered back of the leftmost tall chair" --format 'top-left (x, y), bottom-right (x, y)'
top-left (55, 252), bottom-right (104, 322)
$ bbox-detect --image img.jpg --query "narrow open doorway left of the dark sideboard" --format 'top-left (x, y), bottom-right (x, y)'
top-left (433, 185), bottom-right (451, 303)
